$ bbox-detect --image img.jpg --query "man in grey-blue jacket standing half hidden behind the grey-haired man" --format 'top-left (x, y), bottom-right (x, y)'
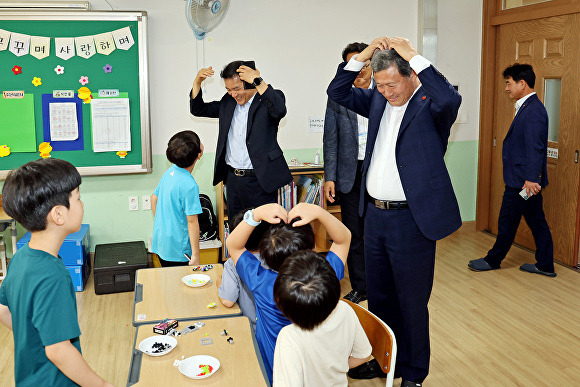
top-left (322, 43), bottom-right (373, 304)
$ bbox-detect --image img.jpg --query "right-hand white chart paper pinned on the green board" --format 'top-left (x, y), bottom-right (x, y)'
top-left (91, 98), bottom-right (131, 152)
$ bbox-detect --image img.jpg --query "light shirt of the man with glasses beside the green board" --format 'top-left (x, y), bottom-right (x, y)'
top-left (226, 94), bottom-right (256, 169)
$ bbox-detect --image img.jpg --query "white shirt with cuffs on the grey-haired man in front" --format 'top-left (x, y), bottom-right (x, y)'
top-left (344, 55), bottom-right (431, 201)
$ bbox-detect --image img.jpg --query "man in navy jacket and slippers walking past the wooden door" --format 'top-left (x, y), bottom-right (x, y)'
top-left (468, 63), bottom-right (556, 277)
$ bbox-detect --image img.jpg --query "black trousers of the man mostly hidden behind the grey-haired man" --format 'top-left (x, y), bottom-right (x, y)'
top-left (336, 160), bottom-right (367, 293)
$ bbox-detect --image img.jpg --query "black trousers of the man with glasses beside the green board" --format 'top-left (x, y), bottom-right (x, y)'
top-left (225, 170), bottom-right (278, 222)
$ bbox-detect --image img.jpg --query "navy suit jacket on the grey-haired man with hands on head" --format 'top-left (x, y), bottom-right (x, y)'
top-left (327, 63), bottom-right (461, 240)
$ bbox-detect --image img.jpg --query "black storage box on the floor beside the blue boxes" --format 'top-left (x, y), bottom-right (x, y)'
top-left (94, 241), bottom-right (149, 294)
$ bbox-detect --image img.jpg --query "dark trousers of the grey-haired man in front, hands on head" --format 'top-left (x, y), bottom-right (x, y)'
top-left (365, 203), bottom-right (436, 383)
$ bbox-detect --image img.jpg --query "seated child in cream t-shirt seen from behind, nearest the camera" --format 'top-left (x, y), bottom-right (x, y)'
top-left (274, 250), bottom-right (372, 387)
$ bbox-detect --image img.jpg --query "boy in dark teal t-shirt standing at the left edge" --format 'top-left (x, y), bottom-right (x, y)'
top-left (0, 158), bottom-right (112, 386)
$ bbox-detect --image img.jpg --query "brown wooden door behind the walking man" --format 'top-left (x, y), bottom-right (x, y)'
top-left (491, 14), bottom-right (580, 266)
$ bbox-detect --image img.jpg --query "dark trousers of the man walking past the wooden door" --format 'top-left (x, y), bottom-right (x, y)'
top-left (485, 186), bottom-right (554, 273)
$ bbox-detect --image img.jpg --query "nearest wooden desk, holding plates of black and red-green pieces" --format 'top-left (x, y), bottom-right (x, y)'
top-left (127, 317), bottom-right (270, 387)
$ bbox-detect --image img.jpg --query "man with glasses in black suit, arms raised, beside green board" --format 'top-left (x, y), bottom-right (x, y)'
top-left (190, 61), bottom-right (292, 219)
